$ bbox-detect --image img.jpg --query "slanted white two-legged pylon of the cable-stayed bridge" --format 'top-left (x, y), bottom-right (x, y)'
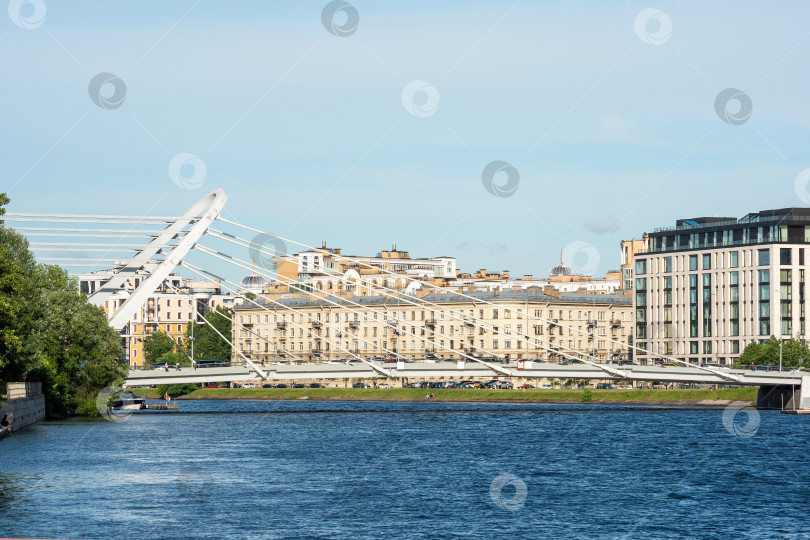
top-left (88, 189), bottom-right (228, 332)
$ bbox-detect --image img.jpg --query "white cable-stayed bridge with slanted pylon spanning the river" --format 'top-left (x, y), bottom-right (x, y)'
top-left (9, 189), bottom-right (810, 414)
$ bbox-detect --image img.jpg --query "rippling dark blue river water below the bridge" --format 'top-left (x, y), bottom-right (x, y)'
top-left (0, 400), bottom-right (810, 539)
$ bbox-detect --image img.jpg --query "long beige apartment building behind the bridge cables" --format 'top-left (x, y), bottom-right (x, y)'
top-left (227, 289), bottom-right (633, 362)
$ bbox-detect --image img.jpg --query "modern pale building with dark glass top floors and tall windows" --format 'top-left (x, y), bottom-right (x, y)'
top-left (633, 208), bottom-right (810, 365)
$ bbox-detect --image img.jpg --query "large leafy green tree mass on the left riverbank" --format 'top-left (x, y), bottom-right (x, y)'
top-left (0, 194), bottom-right (127, 416)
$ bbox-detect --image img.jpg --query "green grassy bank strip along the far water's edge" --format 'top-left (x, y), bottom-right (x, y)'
top-left (133, 388), bottom-right (757, 405)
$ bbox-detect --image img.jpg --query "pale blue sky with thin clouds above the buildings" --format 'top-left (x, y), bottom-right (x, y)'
top-left (0, 0), bottom-right (810, 282)
